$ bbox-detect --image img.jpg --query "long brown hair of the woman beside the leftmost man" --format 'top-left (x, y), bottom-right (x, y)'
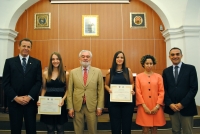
top-left (47, 52), bottom-right (66, 82)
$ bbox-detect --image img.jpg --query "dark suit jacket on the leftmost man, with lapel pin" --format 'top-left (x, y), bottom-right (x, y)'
top-left (3, 56), bottom-right (42, 105)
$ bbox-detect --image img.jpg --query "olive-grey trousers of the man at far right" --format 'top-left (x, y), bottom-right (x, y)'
top-left (169, 112), bottom-right (193, 134)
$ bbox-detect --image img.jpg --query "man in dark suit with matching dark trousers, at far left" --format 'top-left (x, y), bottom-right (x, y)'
top-left (3, 38), bottom-right (42, 134)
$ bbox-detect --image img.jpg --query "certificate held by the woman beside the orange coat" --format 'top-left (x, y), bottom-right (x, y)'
top-left (110, 84), bottom-right (133, 102)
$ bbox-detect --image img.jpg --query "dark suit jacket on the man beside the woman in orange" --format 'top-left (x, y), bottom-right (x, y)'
top-left (163, 63), bottom-right (198, 116)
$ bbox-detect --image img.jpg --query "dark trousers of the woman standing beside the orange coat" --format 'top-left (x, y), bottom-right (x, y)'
top-left (108, 102), bottom-right (134, 134)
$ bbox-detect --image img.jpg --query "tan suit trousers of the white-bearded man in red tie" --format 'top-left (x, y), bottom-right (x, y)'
top-left (73, 104), bottom-right (97, 134)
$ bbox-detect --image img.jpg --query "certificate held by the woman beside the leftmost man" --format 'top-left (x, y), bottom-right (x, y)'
top-left (38, 96), bottom-right (62, 115)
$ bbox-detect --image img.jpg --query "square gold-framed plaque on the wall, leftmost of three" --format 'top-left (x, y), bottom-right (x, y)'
top-left (34, 13), bottom-right (51, 29)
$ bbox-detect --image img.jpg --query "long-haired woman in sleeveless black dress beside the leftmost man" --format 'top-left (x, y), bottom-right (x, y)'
top-left (37, 52), bottom-right (69, 134)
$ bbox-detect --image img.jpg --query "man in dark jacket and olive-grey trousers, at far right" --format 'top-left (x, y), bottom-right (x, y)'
top-left (163, 47), bottom-right (198, 134)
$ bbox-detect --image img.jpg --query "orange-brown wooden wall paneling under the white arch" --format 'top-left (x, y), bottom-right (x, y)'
top-left (14, 0), bottom-right (166, 73)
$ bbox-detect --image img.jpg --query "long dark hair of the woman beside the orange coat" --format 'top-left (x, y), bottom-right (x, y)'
top-left (110, 51), bottom-right (130, 82)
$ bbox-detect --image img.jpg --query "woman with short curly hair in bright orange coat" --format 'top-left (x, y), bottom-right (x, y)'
top-left (136, 55), bottom-right (166, 134)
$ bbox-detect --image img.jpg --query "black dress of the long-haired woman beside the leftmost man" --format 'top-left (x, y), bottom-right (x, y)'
top-left (40, 79), bottom-right (68, 125)
